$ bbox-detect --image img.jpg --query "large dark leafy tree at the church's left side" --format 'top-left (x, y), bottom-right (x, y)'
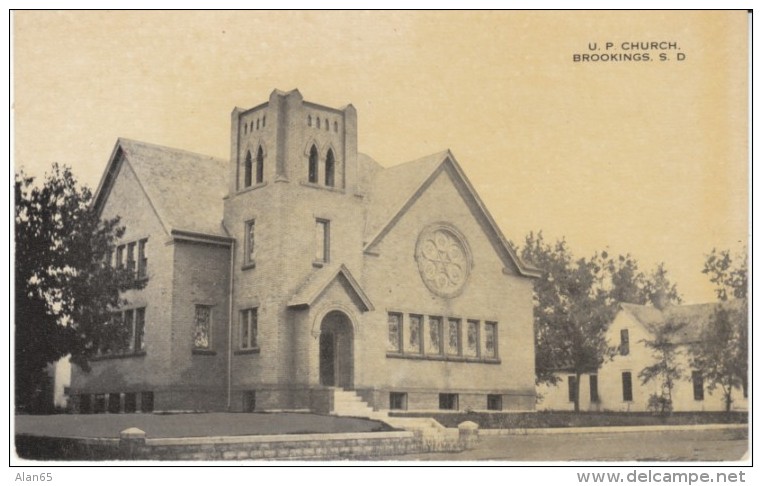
top-left (15, 164), bottom-right (145, 411)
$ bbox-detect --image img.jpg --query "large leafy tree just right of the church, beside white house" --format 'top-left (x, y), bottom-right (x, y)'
top-left (521, 232), bottom-right (615, 412)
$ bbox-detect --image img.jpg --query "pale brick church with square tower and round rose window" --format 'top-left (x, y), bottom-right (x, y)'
top-left (70, 90), bottom-right (539, 413)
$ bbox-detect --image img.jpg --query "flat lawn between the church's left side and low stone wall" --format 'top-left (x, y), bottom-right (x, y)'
top-left (15, 413), bottom-right (392, 438)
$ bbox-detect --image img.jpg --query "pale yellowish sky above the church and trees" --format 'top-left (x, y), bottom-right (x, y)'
top-left (12, 11), bottom-right (750, 303)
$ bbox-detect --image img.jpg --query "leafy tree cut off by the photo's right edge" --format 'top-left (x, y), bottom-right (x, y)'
top-left (692, 249), bottom-right (749, 412)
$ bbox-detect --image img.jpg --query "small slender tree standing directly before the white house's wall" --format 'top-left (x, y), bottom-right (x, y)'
top-left (638, 321), bottom-right (686, 414)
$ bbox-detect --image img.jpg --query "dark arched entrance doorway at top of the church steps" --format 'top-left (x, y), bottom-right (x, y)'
top-left (320, 311), bottom-right (354, 388)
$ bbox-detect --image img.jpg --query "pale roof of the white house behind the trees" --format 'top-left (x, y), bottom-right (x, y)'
top-left (620, 301), bottom-right (739, 344)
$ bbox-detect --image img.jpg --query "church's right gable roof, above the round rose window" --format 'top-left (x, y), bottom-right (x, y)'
top-left (364, 150), bottom-right (540, 277)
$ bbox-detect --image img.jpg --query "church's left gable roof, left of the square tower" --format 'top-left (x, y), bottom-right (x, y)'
top-left (94, 138), bottom-right (227, 237)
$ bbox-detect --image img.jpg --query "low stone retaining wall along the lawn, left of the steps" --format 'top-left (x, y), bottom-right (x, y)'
top-left (16, 432), bottom-right (440, 461)
